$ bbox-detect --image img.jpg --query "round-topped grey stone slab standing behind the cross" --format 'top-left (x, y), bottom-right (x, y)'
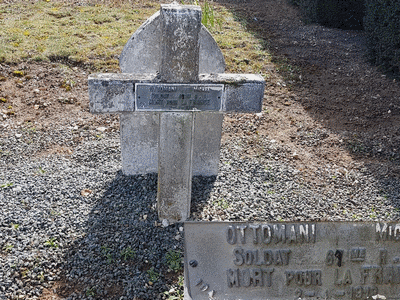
top-left (119, 7), bottom-right (225, 176)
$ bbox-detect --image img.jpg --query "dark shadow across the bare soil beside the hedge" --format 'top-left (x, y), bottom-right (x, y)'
top-left (218, 0), bottom-right (400, 213)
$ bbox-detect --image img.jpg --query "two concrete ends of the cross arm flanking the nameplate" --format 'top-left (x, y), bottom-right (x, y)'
top-left (88, 73), bottom-right (265, 113)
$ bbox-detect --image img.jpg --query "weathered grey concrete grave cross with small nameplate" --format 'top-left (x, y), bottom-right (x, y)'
top-left (88, 3), bottom-right (265, 222)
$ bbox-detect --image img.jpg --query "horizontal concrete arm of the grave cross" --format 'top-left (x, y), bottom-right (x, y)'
top-left (88, 73), bottom-right (265, 113)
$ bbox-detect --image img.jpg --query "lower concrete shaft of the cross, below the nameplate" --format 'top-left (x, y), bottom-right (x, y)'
top-left (157, 113), bottom-right (193, 223)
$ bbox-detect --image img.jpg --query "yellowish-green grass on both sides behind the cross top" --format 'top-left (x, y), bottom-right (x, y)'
top-left (0, 1), bottom-right (271, 75)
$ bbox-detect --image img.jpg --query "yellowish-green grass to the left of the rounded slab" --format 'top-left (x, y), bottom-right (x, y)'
top-left (0, 1), bottom-right (159, 69)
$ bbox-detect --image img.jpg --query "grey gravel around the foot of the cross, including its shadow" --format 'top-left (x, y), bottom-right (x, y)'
top-left (0, 115), bottom-right (400, 299)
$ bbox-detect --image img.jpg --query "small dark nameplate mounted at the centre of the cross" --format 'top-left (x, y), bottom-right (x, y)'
top-left (135, 83), bottom-right (224, 111)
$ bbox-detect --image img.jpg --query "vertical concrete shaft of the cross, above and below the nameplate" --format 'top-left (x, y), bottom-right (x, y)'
top-left (157, 4), bottom-right (201, 222)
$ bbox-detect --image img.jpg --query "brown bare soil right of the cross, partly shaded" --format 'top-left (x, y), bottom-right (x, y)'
top-left (220, 0), bottom-right (400, 184)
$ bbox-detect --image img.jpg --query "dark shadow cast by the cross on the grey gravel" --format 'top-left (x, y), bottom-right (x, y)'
top-left (53, 172), bottom-right (183, 299)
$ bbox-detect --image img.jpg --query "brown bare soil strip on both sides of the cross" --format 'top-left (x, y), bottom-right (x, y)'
top-left (0, 0), bottom-right (400, 185)
